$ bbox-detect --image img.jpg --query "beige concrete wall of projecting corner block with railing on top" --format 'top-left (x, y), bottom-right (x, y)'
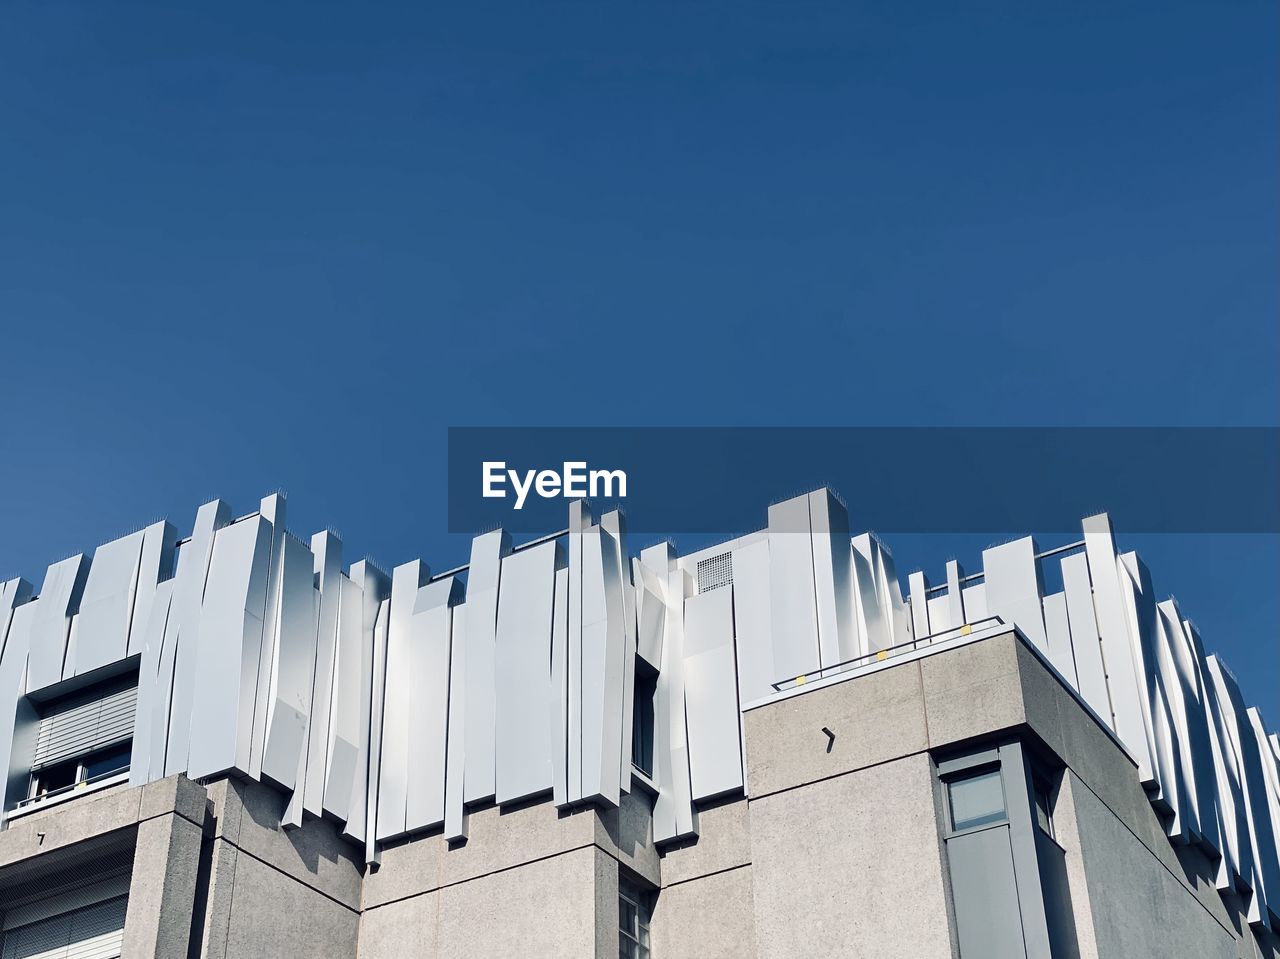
top-left (745, 634), bottom-right (1274, 959)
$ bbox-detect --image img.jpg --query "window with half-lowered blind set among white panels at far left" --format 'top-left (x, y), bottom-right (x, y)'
top-left (26, 676), bottom-right (138, 803)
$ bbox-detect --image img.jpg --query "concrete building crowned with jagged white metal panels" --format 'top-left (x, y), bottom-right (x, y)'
top-left (0, 490), bottom-right (1280, 959)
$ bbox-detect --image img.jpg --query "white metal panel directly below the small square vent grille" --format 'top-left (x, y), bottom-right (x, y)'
top-left (684, 583), bottom-right (742, 800)
